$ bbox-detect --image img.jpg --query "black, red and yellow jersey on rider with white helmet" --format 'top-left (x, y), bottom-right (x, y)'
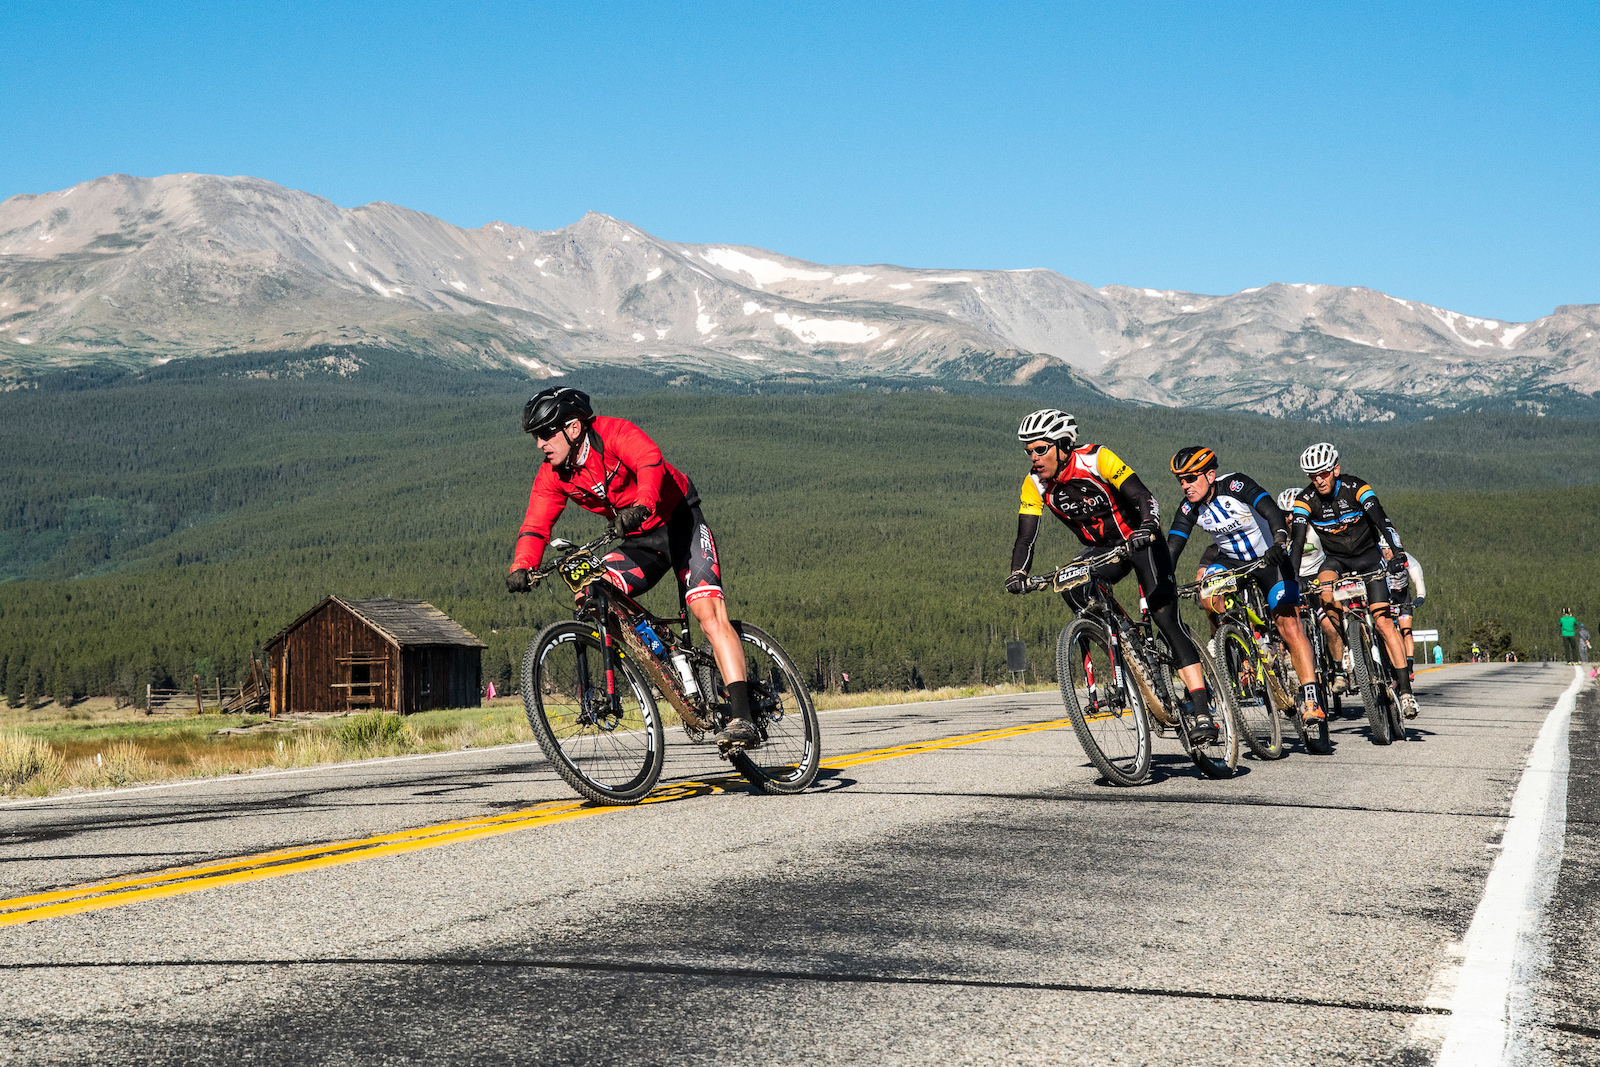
top-left (1018, 445), bottom-right (1158, 547)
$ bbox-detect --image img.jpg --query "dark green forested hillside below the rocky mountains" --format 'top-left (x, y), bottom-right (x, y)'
top-left (0, 363), bottom-right (1600, 710)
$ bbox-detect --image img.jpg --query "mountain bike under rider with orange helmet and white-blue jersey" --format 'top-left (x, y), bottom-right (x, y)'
top-left (1186, 560), bottom-right (1292, 760)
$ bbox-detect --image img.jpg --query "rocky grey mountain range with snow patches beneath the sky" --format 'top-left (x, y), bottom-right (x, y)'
top-left (0, 174), bottom-right (1600, 421)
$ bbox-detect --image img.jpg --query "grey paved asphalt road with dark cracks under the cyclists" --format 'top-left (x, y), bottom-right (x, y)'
top-left (0, 664), bottom-right (1600, 1065)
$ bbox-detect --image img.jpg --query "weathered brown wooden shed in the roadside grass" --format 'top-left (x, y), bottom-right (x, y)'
top-left (267, 597), bottom-right (486, 715)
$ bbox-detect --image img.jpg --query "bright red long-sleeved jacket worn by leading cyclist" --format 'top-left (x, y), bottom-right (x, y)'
top-left (510, 416), bottom-right (690, 571)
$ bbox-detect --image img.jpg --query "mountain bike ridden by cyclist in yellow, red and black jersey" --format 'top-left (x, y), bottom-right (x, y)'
top-left (1024, 545), bottom-right (1238, 785)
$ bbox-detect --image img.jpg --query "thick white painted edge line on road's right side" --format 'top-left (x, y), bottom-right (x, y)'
top-left (1435, 669), bottom-right (1586, 1067)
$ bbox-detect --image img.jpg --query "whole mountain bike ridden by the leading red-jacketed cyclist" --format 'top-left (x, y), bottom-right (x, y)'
top-left (522, 530), bottom-right (822, 805)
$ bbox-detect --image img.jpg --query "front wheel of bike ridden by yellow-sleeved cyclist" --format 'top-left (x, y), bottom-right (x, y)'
top-left (1056, 619), bottom-right (1150, 785)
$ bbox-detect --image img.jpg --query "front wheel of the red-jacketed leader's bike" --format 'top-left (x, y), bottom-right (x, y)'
top-left (522, 622), bottom-right (666, 805)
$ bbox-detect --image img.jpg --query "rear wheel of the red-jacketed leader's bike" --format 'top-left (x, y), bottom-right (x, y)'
top-left (726, 622), bottom-right (822, 793)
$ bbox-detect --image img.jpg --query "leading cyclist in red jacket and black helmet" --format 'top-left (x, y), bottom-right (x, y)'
top-left (506, 386), bottom-right (760, 745)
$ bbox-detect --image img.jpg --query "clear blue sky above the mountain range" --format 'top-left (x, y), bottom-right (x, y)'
top-left (0, 0), bottom-right (1600, 320)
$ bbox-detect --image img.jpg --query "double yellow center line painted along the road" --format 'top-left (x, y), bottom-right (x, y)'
top-left (0, 718), bottom-right (1070, 926)
